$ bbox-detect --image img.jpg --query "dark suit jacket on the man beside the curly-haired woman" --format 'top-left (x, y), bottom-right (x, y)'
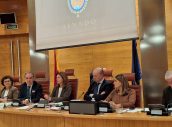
top-left (19, 81), bottom-right (42, 103)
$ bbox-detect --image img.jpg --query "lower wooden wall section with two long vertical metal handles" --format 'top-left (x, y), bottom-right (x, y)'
top-left (0, 35), bottom-right (30, 89)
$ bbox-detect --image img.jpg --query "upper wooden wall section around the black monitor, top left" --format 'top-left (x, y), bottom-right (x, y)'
top-left (0, 0), bottom-right (28, 35)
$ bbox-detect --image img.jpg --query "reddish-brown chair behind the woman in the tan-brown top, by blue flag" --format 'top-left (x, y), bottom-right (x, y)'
top-left (124, 73), bottom-right (141, 107)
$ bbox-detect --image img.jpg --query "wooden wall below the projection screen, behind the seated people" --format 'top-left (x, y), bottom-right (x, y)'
top-left (49, 41), bottom-right (132, 96)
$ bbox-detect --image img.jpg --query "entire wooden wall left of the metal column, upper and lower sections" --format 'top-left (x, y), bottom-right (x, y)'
top-left (0, 0), bottom-right (30, 90)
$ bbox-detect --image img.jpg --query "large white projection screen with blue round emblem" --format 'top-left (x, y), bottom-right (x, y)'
top-left (35, 0), bottom-right (138, 50)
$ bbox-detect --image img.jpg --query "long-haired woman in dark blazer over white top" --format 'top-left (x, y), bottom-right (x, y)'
top-left (44, 72), bottom-right (72, 102)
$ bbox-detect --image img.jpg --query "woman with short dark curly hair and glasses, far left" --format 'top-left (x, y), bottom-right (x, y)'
top-left (0, 75), bottom-right (19, 102)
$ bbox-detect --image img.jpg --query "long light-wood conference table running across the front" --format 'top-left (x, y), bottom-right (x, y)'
top-left (0, 107), bottom-right (172, 127)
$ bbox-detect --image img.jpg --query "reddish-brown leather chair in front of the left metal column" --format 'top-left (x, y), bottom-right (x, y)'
top-left (35, 71), bottom-right (50, 95)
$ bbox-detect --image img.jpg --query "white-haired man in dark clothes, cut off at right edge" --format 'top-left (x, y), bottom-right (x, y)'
top-left (162, 71), bottom-right (172, 107)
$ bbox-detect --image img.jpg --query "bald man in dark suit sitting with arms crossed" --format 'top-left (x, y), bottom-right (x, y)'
top-left (84, 67), bottom-right (113, 101)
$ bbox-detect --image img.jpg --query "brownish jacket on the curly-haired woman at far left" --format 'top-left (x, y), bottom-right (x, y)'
top-left (1, 86), bottom-right (19, 101)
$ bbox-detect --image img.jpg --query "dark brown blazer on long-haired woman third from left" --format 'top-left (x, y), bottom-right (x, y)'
top-left (51, 85), bottom-right (72, 102)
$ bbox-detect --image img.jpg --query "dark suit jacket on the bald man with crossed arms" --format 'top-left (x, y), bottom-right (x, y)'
top-left (84, 79), bottom-right (114, 101)
